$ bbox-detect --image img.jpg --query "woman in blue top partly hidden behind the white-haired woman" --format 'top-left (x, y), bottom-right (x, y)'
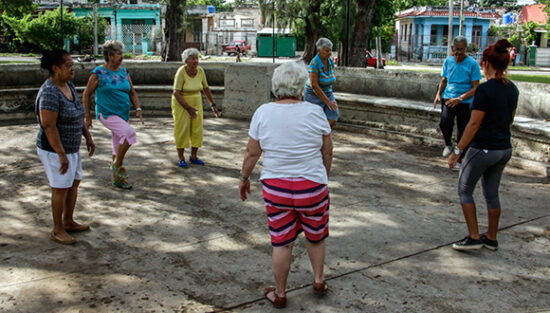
top-left (304, 38), bottom-right (339, 128)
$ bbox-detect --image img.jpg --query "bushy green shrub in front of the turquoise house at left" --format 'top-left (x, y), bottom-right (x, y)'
top-left (4, 8), bottom-right (77, 49)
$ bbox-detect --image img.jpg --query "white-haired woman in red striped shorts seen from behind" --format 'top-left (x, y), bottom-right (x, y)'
top-left (239, 62), bottom-right (332, 308)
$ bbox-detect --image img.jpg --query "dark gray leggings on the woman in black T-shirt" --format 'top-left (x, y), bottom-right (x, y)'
top-left (458, 148), bottom-right (512, 209)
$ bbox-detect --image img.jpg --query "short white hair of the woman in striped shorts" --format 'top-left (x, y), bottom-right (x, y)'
top-left (271, 61), bottom-right (308, 98)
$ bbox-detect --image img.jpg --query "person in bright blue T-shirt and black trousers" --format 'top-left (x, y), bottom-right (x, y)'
top-left (434, 36), bottom-right (481, 166)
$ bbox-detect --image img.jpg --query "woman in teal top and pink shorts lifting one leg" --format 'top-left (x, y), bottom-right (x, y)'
top-left (82, 40), bottom-right (143, 189)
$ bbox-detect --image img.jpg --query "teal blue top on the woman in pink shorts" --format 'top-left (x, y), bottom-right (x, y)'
top-left (92, 66), bottom-right (130, 121)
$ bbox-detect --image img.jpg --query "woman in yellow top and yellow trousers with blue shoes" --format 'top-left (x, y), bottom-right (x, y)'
top-left (172, 48), bottom-right (219, 168)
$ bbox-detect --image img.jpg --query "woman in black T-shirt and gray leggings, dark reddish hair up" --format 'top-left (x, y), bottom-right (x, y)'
top-left (448, 39), bottom-right (519, 250)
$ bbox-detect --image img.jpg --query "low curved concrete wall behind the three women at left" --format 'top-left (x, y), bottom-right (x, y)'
top-left (0, 62), bottom-right (228, 121)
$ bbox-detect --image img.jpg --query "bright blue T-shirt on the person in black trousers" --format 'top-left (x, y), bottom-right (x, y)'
top-left (441, 56), bottom-right (481, 103)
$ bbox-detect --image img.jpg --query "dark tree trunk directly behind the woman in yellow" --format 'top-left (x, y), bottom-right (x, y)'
top-left (162, 0), bottom-right (187, 62)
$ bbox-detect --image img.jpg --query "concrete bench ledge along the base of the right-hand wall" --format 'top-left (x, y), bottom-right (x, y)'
top-left (335, 93), bottom-right (550, 164)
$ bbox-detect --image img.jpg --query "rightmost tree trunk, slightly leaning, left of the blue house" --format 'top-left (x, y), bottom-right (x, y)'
top-left (349, 0), bottom-right (376, 67)
